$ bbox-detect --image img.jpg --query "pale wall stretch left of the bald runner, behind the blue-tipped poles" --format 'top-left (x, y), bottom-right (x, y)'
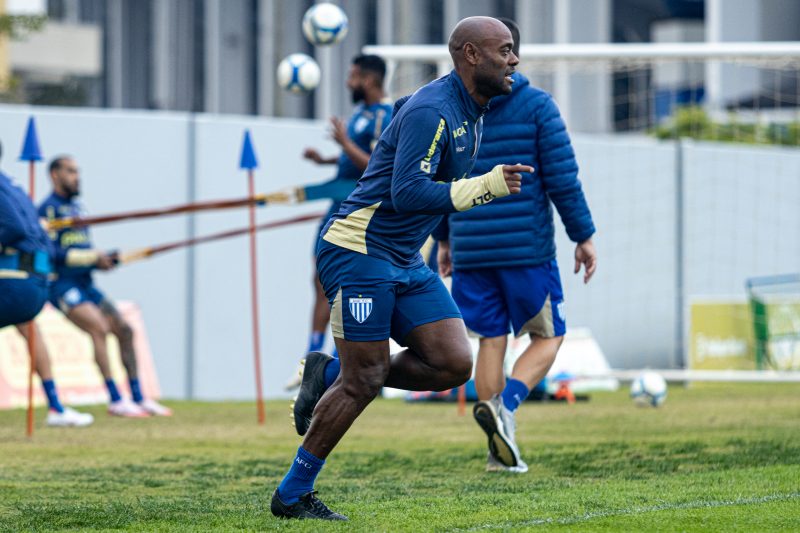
top-left (0, 106), bottom-right (336, 399)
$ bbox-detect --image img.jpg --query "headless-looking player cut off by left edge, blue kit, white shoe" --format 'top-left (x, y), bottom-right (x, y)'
top-left (0, 139), bottom-right (94, 426)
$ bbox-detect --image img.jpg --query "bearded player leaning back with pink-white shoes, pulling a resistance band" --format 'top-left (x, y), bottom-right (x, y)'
top-left (39, 156), bottom-right (172, 418)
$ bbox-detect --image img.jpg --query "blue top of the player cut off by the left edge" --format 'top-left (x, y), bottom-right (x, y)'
top-left (0, 172), bottom-right (50, 256)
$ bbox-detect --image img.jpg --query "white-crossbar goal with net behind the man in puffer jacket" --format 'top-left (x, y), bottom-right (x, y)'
top-left (364, 42), bottom-right (800, 370)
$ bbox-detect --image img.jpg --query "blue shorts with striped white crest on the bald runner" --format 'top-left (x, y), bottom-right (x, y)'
top-left (317, 239), bottom-right (461, 344)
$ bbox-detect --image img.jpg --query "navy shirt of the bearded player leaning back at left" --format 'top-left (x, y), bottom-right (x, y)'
top-left (39, 193), bottom-right (95, 283)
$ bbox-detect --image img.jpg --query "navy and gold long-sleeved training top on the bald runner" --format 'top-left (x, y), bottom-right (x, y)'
top-left (321, 71), bottom-right (493, 267)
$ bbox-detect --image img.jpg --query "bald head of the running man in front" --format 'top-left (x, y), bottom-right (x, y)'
top-left (447, 17), bottom-right (519, 105)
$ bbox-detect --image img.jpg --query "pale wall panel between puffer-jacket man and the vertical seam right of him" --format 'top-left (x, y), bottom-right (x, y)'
top-left (556, 135), bottom-right (677, 368)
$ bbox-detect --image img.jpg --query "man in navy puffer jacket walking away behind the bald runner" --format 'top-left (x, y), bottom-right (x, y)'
top-left (434, 19), bottom-right (597, 472)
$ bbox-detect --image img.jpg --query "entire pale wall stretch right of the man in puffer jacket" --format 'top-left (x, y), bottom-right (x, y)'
top-left (556, 135), bottom-right (800, 368)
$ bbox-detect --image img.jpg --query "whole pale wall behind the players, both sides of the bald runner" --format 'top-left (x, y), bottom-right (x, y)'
top-left (0, 106), bottom-right (800, 399)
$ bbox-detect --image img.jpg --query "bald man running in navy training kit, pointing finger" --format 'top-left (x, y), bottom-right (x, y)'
top-left (271, 17), bottom-right (533, 520)
